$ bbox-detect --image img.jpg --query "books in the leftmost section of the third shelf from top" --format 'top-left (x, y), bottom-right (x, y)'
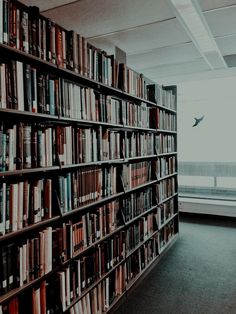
top-left (0, 122), bottom-right (58, 171)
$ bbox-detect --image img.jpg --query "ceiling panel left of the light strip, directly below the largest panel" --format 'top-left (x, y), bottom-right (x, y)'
top-left (90, 19), bottom-right (190, 54)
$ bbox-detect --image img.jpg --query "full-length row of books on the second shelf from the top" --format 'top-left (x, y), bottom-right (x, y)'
top-left (0, 60), bottom-right (176, 130)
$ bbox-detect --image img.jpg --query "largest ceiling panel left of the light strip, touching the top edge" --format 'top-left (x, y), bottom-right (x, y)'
top-left (42, 0), bottom-right (173, 37)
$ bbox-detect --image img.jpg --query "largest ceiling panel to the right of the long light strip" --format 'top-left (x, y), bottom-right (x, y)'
top-left (204, 6), bottom-right (236, 36)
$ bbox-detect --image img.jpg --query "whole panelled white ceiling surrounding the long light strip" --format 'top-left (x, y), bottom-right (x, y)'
top-left (22, 0), bottom-right (236, 84)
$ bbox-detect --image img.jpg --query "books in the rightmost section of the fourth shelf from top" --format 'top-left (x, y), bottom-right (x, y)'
top-left (155, 156), bottom-right (177, 178)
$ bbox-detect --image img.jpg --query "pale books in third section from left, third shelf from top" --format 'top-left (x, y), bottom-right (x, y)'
top-left (125, 132), bottom-right (155, 158)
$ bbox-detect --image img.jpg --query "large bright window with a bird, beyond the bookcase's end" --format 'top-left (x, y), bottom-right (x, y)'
top-left (178, 77), bottom-right (236, 199)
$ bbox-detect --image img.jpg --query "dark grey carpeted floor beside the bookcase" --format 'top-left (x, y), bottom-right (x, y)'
top-left (115, 216), bottom-right (236, 314)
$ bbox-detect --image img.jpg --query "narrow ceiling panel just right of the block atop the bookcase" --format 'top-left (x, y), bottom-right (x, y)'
top-left (127, 43), bottom-right (201, 71)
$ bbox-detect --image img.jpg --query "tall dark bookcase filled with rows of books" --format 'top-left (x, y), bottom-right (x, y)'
top-left (0, 0), bottom-right (179, 314)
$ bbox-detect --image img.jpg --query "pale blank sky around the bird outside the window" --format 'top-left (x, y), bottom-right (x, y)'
top-left (177, 77), bottom-right (236, 162)
